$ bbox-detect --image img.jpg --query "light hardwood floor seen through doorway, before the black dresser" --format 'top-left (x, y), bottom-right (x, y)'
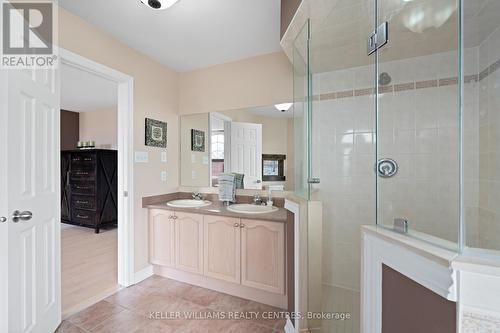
top-left (61, 224), bottom-right (118, 318)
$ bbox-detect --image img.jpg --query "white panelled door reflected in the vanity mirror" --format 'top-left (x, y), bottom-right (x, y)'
top-left (231, 122), bottom-right (262, 189)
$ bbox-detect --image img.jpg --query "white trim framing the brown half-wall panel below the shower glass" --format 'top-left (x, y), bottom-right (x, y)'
top-left (361, 226), bottom-right (458, 333)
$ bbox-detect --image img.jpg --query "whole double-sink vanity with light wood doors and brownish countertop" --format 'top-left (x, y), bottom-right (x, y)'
top-left (143, 192), bottom-right (293, 309)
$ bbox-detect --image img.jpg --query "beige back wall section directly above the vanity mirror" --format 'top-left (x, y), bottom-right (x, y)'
top-left (179, 52), bottom-right (293, 114)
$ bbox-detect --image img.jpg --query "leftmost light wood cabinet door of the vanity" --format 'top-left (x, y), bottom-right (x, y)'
top-left (149, 209), bottom-right (175, 267)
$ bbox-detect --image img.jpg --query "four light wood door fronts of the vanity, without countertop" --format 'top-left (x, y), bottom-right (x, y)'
top-left (149, 209), bottom-right (286, 295)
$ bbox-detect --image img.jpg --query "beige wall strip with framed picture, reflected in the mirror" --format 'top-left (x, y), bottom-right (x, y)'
top-left (180, 113), bottom-right (210, 187)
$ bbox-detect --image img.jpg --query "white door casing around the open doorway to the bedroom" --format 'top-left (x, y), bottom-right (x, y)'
top-left (59, 48), bottom-right (135, 287)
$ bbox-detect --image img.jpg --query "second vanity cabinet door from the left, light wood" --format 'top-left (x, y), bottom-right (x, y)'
top-left (175, 212), bottom-right (203, 274)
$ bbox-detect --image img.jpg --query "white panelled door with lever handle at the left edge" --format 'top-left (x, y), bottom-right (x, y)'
top-left (0, 70), bottom-right (61, 333)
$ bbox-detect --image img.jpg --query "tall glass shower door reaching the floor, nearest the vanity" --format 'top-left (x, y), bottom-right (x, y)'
top-left (306, 0), bottom-right (376, 333)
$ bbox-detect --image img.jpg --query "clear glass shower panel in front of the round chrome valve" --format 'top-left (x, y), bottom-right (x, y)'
top-left (377, 0), bottom-right (461, 249)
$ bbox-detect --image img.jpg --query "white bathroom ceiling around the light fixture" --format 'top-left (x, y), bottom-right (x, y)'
top-left (59, 0), bottom-right (281, 72)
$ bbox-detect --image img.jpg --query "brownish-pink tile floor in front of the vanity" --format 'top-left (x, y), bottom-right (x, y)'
top-left (56, 275), bottom-right (285, 333)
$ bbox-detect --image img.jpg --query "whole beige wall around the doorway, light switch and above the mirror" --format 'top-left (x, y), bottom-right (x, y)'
top-left (59, 8), bottom-right (293, 271)
